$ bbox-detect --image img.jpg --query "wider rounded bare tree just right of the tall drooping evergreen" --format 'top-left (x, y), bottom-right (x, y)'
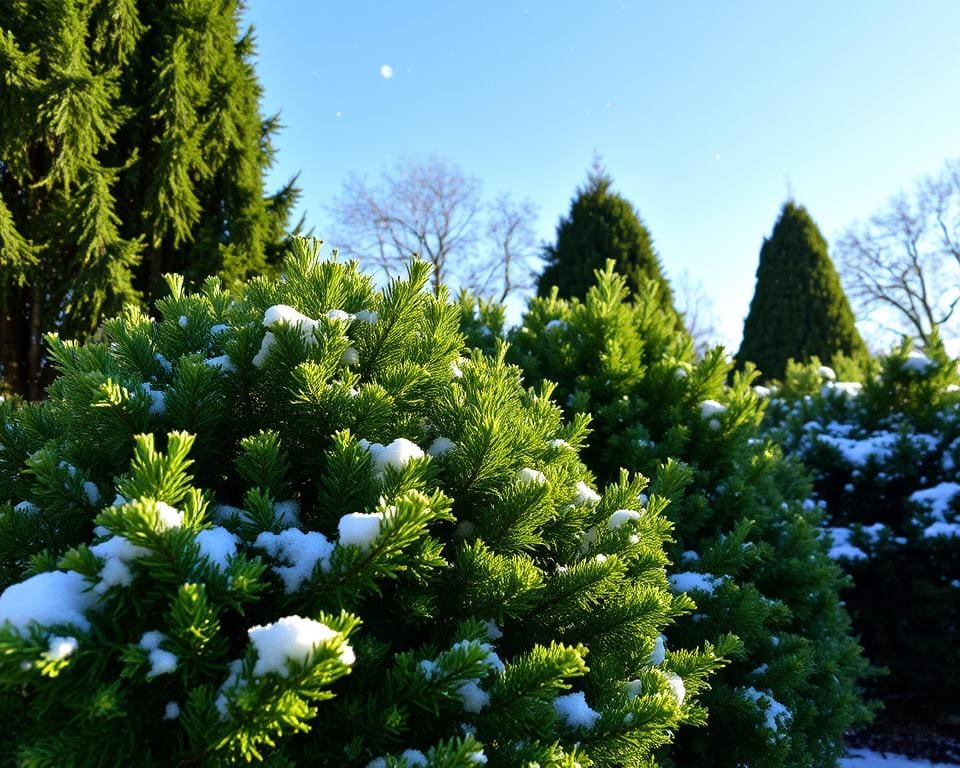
top-left (333, 156), bottom-right (483, 290)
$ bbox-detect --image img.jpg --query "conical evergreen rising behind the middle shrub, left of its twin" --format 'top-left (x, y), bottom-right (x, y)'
top-left (537, 162), bottom-right (676, 314)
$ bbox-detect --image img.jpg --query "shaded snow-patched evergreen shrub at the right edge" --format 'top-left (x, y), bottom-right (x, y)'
top-left (765, 338), bottom-right (960, 728)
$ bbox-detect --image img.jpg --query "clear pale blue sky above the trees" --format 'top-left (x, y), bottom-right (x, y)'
top-left (246, 0), bottom-right (960, 348)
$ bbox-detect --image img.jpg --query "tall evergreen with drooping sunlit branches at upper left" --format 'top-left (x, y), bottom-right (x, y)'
top-left (0, 0), bottom-right (297, 397)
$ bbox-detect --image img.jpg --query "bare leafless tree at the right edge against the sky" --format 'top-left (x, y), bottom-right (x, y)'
top-left (837, 162), bottom-right (960, 344)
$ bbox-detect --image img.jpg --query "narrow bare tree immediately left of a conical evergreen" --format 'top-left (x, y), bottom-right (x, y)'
top-left (468, 194), bottom-right (539, 302)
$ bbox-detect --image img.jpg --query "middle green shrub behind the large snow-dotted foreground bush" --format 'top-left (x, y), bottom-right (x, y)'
top-left (470, 265), bottom-right (868, 768)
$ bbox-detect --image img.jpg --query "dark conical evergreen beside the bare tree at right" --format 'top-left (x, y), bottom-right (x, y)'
top-left (736, 200), bottom-right (866, 379)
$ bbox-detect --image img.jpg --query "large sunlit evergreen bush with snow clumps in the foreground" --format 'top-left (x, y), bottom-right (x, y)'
top-left (0, 240), bottom-right (731, 768)
